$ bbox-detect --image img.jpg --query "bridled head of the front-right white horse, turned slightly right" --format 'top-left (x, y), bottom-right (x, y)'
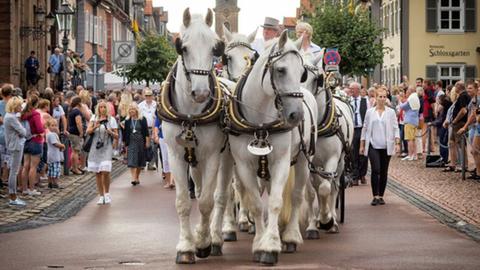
top-left (262, 30), bottom-right (307, 126)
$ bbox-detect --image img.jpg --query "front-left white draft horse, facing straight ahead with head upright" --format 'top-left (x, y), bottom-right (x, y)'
top-left (157, 8), bottom-right (224, 264)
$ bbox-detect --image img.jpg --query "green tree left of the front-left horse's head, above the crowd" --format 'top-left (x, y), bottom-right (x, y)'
top-left (118, 34), bottom-right (177, 86)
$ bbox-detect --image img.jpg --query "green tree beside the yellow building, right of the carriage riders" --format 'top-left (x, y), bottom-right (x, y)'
top-left (308, 1), bottom-right (384, 76)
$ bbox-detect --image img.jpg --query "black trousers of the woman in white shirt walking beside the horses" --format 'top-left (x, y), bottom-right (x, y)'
top-left (368, 146), bottom-right (390, 197)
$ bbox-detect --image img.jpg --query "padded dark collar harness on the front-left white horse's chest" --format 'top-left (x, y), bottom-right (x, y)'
top-left (157, 61), bottom-right (224, 167)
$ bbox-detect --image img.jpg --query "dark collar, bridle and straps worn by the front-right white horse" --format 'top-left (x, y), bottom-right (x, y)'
top-left (221, 45), bottom-right (315, 181)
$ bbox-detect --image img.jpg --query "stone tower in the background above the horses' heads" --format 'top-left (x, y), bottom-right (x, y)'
top-left (213, 0), bottom-right (240, 36)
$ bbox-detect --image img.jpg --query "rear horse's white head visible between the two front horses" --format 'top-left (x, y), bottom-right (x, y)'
top-left (222, 26), bottom-right (258, 81)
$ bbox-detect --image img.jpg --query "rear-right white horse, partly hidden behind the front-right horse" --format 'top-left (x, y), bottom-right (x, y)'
top-left (305, 51), bottom-right (353, 239)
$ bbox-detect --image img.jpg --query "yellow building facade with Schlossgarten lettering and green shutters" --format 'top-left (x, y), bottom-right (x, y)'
top-left (374, 0), bottom-right (480, 85)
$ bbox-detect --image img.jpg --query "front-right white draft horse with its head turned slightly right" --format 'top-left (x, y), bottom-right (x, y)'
top-left (229, 31), bottom-right (317, 265)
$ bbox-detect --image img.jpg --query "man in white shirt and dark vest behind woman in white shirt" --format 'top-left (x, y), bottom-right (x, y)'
top-left (349, 82), bottom-right (370, 186)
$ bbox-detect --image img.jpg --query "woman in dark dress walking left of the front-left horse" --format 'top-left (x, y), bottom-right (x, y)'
top-left (124, 103), bottom-right (150, 186)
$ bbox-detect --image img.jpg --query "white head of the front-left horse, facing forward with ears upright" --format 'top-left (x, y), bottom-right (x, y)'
top-left (175, 8), bottom-right (225, 103)
